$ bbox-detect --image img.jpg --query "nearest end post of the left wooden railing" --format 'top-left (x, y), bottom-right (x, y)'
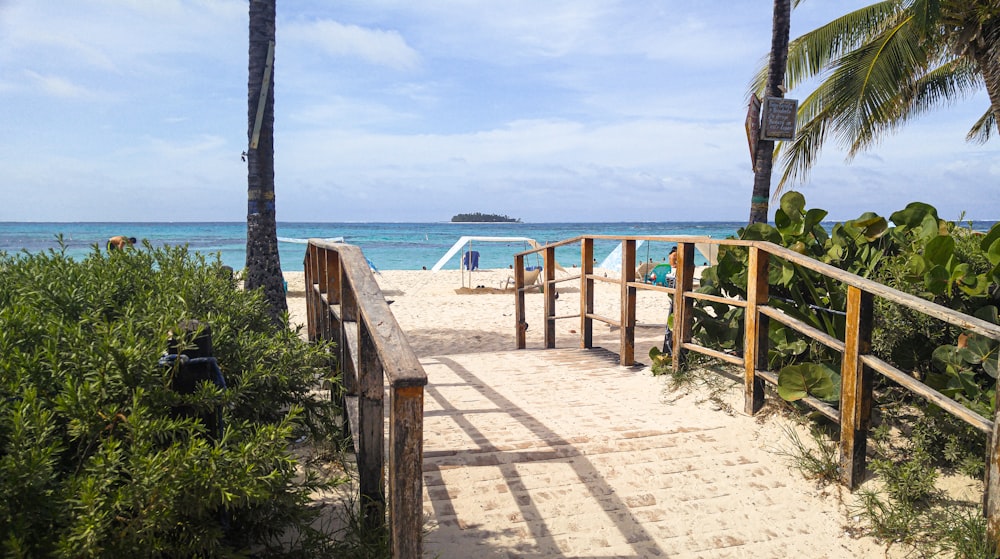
top-left (389, 386), bottom-right (424, 559)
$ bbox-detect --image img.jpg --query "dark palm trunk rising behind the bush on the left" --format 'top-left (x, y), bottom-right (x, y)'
top-left (244, 0), bottom-right (288, 321)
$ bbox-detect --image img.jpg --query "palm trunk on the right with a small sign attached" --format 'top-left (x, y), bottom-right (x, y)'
top-left (750, 0), bottom-right (792, 223)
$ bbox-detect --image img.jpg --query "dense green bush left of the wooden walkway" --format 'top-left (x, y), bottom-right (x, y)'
top-left (0, 244), bottom-right (336, 557)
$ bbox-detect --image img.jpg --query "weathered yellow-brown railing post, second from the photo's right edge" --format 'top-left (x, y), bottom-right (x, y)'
top-left (840, 286), bottom-right (873, 490)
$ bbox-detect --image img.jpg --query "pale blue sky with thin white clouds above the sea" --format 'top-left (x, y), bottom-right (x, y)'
top-left (0, 0), bottom-right (1000, 222)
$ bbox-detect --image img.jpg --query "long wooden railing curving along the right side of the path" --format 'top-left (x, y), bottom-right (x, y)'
top-left (514, 236), bottom-right (1000, 544)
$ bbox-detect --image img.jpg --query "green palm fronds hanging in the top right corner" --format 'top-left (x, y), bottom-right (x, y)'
top-left (752, 0), bottom-right (1000, 192)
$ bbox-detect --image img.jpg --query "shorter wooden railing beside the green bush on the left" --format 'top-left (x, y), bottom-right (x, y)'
top-left (305, 239), bottom-right (427, 558)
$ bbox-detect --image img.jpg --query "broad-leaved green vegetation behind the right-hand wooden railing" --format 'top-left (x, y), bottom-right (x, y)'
top-left (688, 192), bottom-right (1000, 557)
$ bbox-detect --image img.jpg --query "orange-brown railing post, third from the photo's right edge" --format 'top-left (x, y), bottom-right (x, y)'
top-left (743, 247), bottom-right (770, 415)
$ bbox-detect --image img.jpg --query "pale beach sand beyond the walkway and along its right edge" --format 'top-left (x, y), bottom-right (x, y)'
top-left (285, 269), bottom-right (920, 558)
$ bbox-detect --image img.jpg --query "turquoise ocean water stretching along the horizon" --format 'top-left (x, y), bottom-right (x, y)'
top-left (0, 222), bottom-right (993, 271)
